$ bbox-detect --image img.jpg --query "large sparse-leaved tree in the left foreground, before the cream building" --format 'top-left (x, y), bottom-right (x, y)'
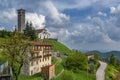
top-left (0, 32), bottom-right (29, 80)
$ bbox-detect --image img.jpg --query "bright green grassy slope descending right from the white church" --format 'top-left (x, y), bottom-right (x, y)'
top-left (44, 39), bottom-right (71, 54)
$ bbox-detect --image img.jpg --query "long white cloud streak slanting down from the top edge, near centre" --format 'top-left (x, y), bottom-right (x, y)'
top-left (43, 1), bottom-right (69, 24)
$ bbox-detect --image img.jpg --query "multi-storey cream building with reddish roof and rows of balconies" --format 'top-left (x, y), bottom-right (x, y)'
top-left (21, 42), bottom-right (53, 75)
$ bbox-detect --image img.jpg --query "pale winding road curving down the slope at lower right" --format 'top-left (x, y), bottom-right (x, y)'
top-left (96, 61), bottom-right (107, 80)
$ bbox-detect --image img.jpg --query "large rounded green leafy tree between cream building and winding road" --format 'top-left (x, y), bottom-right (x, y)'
top-left (65, 53), bottom-right (88, 72)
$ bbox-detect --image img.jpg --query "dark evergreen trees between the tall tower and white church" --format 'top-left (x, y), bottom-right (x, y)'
top-left (24, 22), bottom-right (37, 40)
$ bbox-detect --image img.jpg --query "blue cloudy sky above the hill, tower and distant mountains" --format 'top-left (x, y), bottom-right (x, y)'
top-left (0, 0), bottom-right (120, 51)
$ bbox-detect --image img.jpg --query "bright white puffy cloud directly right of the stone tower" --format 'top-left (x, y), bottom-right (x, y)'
top-left (26, 13), bottom-right (45, 29)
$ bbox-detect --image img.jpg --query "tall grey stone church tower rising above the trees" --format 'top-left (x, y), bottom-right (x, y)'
top-left (18, 9), bottom-right (25, 33)
